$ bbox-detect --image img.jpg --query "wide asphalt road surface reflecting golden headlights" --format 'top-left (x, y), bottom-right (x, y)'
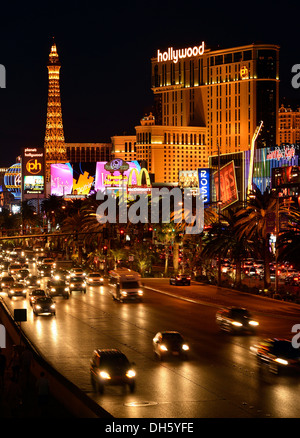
top-left (1, 270), bottom-right (300, 418)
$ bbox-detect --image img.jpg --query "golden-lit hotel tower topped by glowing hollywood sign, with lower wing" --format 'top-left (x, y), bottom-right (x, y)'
top-left (112, 42), bottom-right (279, 184)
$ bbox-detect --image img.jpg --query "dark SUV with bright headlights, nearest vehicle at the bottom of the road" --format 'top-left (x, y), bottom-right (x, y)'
top-left (90, 348), bottom-right (136, 394)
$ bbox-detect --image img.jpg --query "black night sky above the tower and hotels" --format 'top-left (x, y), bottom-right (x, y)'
top-left (0, 0), bottom-right (300, 166)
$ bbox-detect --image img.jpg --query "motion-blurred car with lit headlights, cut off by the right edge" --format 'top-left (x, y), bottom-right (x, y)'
top-left (250, 338), bottom-right (300, 374)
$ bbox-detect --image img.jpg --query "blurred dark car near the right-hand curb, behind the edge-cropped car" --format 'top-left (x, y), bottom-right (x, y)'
top-left (216, 307), bottom-right (259, 334)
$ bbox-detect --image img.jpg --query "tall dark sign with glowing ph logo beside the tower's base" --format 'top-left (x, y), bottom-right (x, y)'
top-left (22, 148), bottom-right (45, 200)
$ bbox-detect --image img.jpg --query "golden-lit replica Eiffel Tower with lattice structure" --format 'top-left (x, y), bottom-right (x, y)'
top-left (44, 41), bottom-right (67, 183)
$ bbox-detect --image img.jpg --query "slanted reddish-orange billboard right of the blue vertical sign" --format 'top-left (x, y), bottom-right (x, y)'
top-left (213, 160), bottom-right (239, 209)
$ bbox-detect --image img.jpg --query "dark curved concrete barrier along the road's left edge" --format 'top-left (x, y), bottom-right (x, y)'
top-left (0, 297), bottom-right (113, 418)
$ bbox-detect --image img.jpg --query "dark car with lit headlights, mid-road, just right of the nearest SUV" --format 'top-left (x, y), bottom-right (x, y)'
top-left (152, 330), bottom-right (190, 360)
